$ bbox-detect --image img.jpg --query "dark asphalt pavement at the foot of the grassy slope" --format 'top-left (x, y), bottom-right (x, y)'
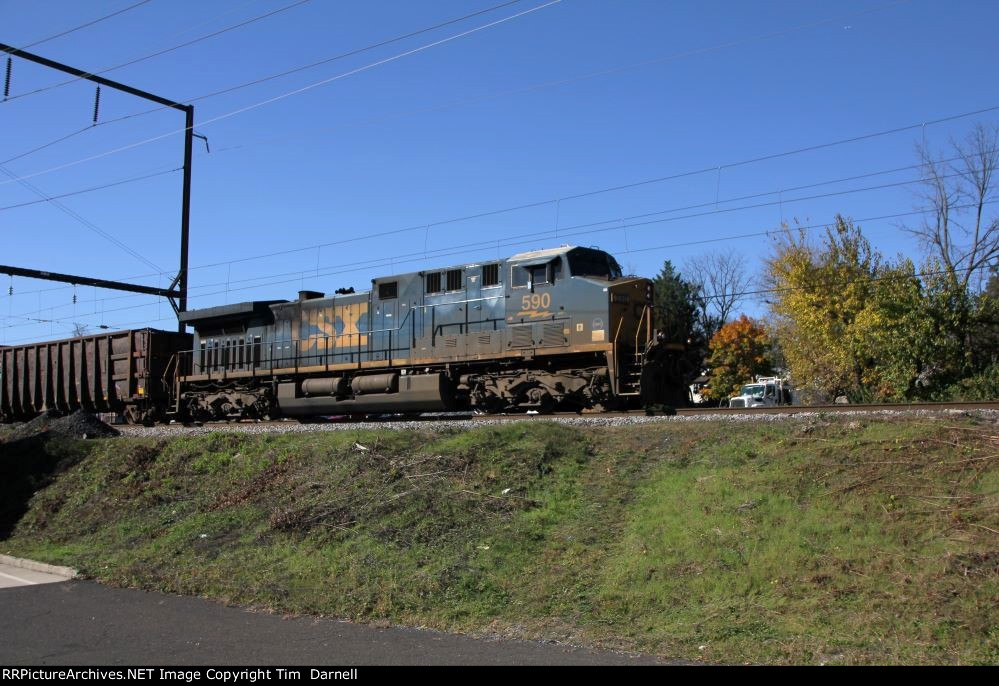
top-left (0, 580), bottom-right (663, 667)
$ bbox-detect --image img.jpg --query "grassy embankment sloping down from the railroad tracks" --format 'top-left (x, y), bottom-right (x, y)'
top-left (0, 418), bottom-right (999, 664)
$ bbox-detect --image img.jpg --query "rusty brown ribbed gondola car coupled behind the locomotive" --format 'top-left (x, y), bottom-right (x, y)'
top-left (0, 329), bottom-right (191, 423)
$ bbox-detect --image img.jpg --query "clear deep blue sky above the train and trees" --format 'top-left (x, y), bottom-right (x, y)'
top-left (0, 0), bottom-right (999, 344)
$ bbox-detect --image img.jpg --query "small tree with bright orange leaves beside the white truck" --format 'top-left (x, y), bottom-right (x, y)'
top-left (701, 315), bottom-right (773, 401)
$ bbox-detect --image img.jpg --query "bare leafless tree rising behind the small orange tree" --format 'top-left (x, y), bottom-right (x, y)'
top-left (684, 250), bottom-right (752, 340)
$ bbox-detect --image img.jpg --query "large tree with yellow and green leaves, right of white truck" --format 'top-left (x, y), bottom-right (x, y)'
top-left (767, 216), bottom-right (994, 402)
